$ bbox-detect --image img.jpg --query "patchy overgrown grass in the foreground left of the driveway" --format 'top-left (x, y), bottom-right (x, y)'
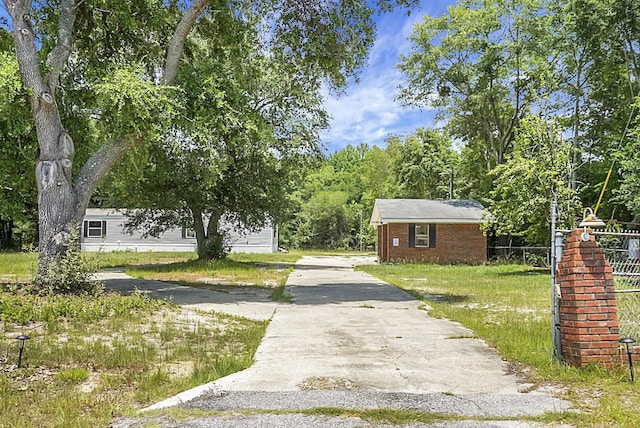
top-left (0, 290), bottom-right (266, 427)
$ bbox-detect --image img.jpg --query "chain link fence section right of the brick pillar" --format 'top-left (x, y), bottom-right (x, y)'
top-left (594, 231), bottom-right (640, 340)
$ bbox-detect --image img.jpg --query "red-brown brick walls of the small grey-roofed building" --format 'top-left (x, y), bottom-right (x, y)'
top-left (378, 223), bottom-right (487, 264)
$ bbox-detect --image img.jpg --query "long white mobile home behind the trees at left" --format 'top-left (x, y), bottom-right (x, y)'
top-left (80, 208), bottom-right (278, 253)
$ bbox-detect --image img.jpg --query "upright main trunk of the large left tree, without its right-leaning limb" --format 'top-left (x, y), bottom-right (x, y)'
top-left (6, 0), bottom-right (80, 278)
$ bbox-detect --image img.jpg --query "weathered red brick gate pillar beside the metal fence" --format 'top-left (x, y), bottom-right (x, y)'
top-left (557, 229), bottom-right (620, 367)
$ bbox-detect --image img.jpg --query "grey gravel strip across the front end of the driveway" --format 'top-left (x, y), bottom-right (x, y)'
top-left (112, 391), bottom-right (565, 428)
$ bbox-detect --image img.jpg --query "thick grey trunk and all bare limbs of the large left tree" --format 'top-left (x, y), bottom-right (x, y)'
top-left (4, 0), bottom-right (208, 280)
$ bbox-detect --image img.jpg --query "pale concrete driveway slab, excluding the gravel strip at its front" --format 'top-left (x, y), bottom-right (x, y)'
top-left (202, 257), bottom-right (519, 394)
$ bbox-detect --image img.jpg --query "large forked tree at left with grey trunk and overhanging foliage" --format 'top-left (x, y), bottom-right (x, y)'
top-left (3, 0), bottom-right (414, 278)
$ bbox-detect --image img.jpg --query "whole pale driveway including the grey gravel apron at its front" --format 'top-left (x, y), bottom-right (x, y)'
top-left (134, 257), bottom-right (570, 426)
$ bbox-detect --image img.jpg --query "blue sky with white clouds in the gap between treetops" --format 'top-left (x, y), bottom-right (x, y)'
top-left (321, 0), bottom-right (454, 153)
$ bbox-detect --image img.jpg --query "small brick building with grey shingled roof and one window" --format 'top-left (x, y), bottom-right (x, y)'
top-left (371, 199), bottom-right (487, 264)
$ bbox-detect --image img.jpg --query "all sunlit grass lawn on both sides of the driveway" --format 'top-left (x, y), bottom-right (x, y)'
top-left (8, 252), bottom-right (640, 427)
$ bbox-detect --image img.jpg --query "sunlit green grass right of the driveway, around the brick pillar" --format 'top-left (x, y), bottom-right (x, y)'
top-left (359, 264), bottom-right (640, 427)
